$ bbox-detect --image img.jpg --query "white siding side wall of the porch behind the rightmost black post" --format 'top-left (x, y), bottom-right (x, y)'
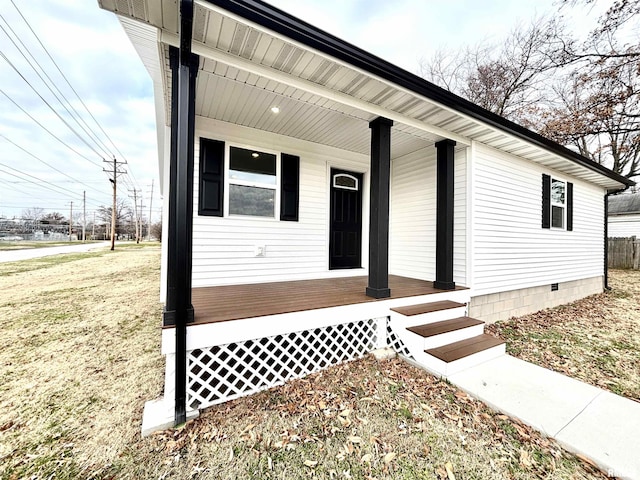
top-left (389, 146), bottom-right (467, 286)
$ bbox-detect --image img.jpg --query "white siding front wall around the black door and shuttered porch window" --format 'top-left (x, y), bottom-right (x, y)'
top-left (193, 117), bottom-right (369, 287)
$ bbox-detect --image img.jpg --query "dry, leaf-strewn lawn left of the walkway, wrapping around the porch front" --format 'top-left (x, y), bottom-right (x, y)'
top-left (0, 246), bottom-right (605, 480)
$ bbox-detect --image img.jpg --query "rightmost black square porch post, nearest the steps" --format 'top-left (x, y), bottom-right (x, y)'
top-left (433, 139), bottom-right (456, 290)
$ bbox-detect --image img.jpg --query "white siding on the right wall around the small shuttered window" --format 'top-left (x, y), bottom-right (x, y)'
top-left (471, 144), bottom-right (605, 295)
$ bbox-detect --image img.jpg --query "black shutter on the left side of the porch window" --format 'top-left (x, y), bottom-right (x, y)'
top-left (198, 138), bottom-right (224, 217)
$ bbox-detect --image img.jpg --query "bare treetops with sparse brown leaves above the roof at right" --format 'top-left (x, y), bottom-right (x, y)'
top-left (420, 0), bottom-right (640, 177)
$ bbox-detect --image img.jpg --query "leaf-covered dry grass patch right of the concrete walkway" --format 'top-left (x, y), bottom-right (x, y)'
top-left (488, 270), bottom-right (640, 401)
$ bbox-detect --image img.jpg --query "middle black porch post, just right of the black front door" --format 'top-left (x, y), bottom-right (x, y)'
top-left (366, 117), bottom-right (393, 298)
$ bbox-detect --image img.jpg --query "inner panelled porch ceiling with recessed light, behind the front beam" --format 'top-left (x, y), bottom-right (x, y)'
top-left (192, 58), bottom-right (439, 158)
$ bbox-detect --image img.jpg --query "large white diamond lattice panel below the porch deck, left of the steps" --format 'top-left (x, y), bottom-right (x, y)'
top-left (187, 319), bottom-right (380, 409)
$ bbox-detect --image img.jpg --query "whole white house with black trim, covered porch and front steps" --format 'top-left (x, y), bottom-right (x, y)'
top-left (99, 0), bottom-right (632, 433)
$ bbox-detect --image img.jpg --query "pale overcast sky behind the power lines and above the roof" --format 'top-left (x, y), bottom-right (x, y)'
top-left (0, 0), bottom-right (603, 221)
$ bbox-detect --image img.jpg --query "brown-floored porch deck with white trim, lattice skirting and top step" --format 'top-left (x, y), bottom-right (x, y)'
top-left (158, 275), bottom-right (472, 418)
